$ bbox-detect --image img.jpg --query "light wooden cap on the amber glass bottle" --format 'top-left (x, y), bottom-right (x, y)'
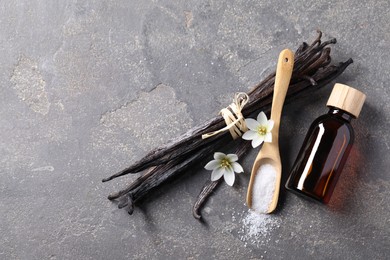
top-left (326, 83), bottom-right (366, 118)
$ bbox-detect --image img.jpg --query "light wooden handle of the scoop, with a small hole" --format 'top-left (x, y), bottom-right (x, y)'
top-left (271, 49), bottom-right (294, 126)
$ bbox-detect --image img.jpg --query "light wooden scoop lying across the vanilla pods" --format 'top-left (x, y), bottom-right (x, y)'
top-left (246, 49), bottom-right (294, 213)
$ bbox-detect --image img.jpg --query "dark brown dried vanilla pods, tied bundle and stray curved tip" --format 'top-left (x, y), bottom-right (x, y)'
top-left (103, 32), bottom-right (353, 218)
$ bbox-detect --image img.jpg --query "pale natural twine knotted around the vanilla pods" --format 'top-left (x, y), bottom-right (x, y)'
top-left (202, 92), bottom-right (249, 139)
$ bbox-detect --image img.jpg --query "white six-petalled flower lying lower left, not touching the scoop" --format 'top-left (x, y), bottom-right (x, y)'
top-left (204, 152), bottom-right (244, 186)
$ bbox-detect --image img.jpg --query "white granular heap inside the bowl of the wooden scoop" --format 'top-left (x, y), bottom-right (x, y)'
top-left (252, 164), bottom-right (276, 213)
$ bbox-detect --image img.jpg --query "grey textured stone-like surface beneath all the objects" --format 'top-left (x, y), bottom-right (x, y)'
top-left (0, 0), bottom-right (390, 259)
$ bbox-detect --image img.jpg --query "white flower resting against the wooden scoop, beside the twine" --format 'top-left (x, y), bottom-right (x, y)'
top-left (242, 112), bottom-right (274, 148)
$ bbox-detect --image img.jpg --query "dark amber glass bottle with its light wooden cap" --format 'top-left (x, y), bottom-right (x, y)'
top-left (286, 83), bottom-right (366, 204)
